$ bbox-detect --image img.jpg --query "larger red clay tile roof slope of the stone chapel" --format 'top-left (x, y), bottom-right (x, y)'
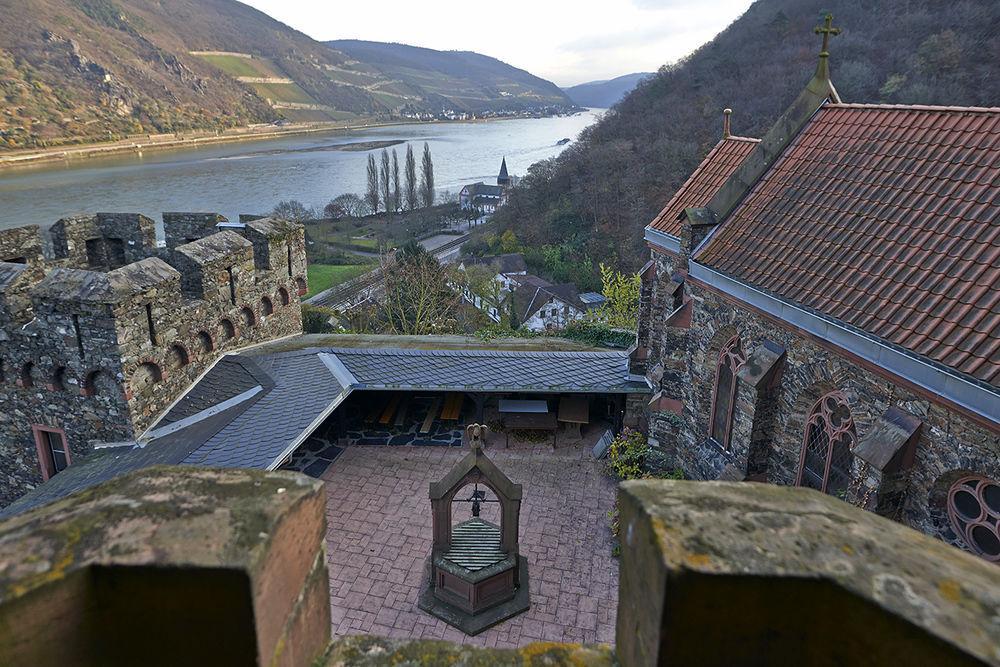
top-left (696, 104), bottom-right (1000, 386)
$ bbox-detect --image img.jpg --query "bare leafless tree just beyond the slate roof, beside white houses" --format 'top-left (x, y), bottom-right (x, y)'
top-left (380, 243), bottom-right (461, 335)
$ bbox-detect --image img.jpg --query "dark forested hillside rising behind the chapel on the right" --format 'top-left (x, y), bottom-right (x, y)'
top-left (497, 0), bottom-right (1000, 275)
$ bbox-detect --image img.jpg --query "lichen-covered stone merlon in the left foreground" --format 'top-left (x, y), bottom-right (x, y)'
top-left (0, 467), bottom-right (330, 665)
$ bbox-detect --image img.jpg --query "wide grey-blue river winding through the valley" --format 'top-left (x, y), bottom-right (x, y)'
top-left (0, 110), bottom-right (600, 229)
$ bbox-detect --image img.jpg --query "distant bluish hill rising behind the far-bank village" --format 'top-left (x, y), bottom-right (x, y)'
top-left (326, 39), bottom-right (573, 112)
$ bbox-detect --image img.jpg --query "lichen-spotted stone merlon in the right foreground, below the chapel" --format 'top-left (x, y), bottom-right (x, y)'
top-left (616, 480), bottom-right (1000, 665)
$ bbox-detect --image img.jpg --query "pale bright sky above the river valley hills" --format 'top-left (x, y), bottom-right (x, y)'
top-left (242, 0), bottom-right (751, 86)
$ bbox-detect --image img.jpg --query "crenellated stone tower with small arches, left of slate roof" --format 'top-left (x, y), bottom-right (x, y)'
top-left (0, 213), bottom-right (307, 504)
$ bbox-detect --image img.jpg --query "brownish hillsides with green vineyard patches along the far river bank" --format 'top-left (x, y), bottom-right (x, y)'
top-left (0, 0), bottom-right (568, 150)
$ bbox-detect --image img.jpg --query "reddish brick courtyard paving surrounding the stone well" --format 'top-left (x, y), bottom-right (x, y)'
top-left (322, 445), bottom-right (618, 647)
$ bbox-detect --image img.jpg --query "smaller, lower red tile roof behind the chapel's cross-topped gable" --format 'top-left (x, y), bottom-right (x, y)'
top-left (649, 137), bottom-right (760, 236)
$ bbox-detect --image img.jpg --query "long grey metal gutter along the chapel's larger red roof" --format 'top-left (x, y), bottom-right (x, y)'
top-left (688, 264), bottom-right (1000, 424)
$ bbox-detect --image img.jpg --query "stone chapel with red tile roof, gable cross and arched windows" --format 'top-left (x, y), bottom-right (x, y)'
top-left (633, 20), bottom-right (1000, 562)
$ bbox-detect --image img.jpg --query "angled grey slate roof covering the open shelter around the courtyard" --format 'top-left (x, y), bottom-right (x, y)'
top-left (0, 348), bottom-right (648, 518)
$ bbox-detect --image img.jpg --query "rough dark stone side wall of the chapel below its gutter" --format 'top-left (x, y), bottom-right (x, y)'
top-left (646, 248), bottom-right (1000, 560)
